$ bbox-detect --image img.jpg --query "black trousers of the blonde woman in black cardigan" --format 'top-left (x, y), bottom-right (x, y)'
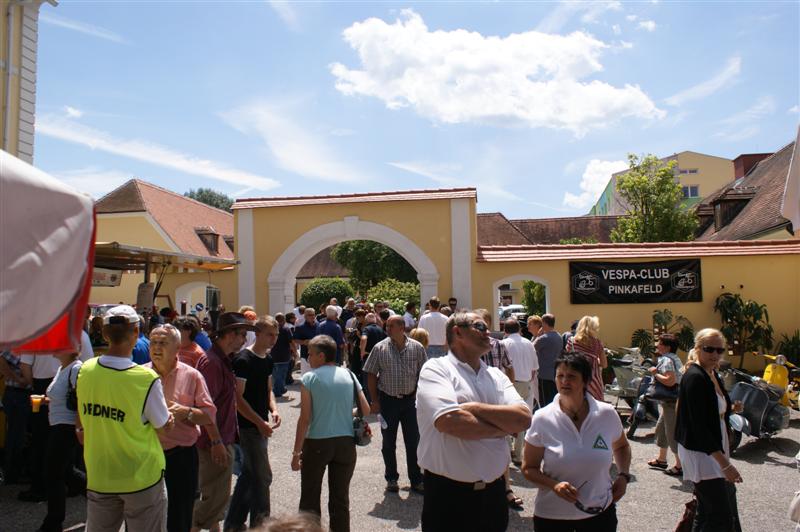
top-left (692, 478), bottom-right (742, 532)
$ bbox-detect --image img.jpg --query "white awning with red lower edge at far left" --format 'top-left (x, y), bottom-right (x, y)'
top-left (0, 150), bottom-right (95, 354)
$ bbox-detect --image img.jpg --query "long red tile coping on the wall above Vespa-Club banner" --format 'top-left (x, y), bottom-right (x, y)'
top-left (477, 240), bottom-right (800, 262)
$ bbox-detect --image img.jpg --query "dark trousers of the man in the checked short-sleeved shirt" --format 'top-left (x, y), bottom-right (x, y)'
top-left (378, 392), bottom-right (422, 486)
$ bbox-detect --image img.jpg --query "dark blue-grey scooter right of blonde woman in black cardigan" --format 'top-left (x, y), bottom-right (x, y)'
top-left (725, 368), bottom-right (789, 452)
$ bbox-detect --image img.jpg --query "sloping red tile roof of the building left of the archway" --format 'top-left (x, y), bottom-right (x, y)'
top-left (96, 179), bottom-right (234, 259)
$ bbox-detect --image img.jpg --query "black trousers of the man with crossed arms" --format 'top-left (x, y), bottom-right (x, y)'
top-left (422, 471), bottom-right (508, 532)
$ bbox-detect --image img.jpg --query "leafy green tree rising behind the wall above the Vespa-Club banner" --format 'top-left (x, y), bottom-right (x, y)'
top-left (611, 154), bottom-right (698, 242)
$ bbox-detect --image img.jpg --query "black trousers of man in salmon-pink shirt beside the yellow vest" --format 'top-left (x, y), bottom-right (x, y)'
top-left (164, 445), bottom-right (198, 532)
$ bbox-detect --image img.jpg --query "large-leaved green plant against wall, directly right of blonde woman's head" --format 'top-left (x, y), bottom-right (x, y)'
top-left (714, 292), bottom-right (773, 369)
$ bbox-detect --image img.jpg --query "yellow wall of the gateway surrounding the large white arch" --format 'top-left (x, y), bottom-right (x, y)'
top-left (250, 199), bottom-right (460, 313)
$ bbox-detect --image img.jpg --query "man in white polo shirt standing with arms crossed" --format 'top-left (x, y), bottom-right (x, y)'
top-left (417, 310), bottom-right (531, 532)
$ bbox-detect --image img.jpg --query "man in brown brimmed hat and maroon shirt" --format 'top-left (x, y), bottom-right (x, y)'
top-left (192, 312), bottom-right (256, 531)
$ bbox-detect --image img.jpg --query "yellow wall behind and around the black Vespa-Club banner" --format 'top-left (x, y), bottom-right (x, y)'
top-left (473, 255), bottom-right (800, 369)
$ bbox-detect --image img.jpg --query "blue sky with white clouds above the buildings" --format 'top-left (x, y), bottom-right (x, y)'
top-left (35, 0), bottom-right (800, 218)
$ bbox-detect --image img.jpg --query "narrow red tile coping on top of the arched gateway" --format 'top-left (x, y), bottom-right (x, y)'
top-left (233, 187), bottom-right (478, 209)
